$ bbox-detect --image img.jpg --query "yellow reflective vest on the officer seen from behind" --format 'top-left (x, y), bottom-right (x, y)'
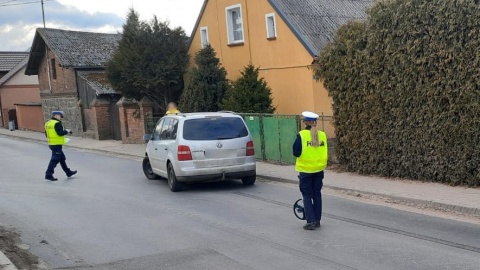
top-left (295, 130), bottom-right (328, 173)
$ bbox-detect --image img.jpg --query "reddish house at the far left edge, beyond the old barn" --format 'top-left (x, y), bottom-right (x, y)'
top-left (0, 51), bottom-right (43, 130)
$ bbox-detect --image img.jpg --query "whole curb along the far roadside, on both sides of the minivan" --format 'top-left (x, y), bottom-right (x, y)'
top-left (0, 134), bottom-right (480, 217)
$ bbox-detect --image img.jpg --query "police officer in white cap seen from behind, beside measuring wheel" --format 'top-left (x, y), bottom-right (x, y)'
top-left (293, 112), bottom-right (328, 230)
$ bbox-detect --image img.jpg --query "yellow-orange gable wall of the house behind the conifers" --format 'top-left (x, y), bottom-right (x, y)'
top-left (190, 0), bottom-right (331, 115)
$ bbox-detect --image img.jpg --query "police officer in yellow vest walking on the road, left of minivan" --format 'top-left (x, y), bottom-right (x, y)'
top-left (45, 111), bottom-right (77, 181)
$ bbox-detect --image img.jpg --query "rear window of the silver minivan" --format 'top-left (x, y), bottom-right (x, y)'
top-left (183, 117), bottom-right (248, 141)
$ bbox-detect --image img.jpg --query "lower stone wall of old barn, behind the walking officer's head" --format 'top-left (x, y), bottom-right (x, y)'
top-left (42, 95), bottom-right (83, 133)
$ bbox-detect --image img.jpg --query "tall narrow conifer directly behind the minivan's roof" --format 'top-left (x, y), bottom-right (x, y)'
top-left (180, 45), bottom-right (229, 112)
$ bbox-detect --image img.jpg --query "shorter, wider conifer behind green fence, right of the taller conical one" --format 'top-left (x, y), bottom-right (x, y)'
top-left (222, 64), bottom-right (275, 113)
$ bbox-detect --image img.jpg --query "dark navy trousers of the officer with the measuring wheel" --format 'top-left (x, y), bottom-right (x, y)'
top-left (298, 171), bottom-right (324, 223)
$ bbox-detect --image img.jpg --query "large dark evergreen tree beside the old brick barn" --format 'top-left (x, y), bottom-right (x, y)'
top-left (106, 9), bottom-right (189, 106)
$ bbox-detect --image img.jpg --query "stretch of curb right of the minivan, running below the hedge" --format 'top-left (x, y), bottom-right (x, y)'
top-left (257, 174), bottom-right (480, 217)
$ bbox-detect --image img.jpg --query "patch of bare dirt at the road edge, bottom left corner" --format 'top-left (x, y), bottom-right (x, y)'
top-left (0, 227), bottom-right (41, 270)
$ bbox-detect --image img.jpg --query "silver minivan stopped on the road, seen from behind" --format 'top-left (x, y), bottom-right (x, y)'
top-left (143, 112), bottom-right (256, 192)
